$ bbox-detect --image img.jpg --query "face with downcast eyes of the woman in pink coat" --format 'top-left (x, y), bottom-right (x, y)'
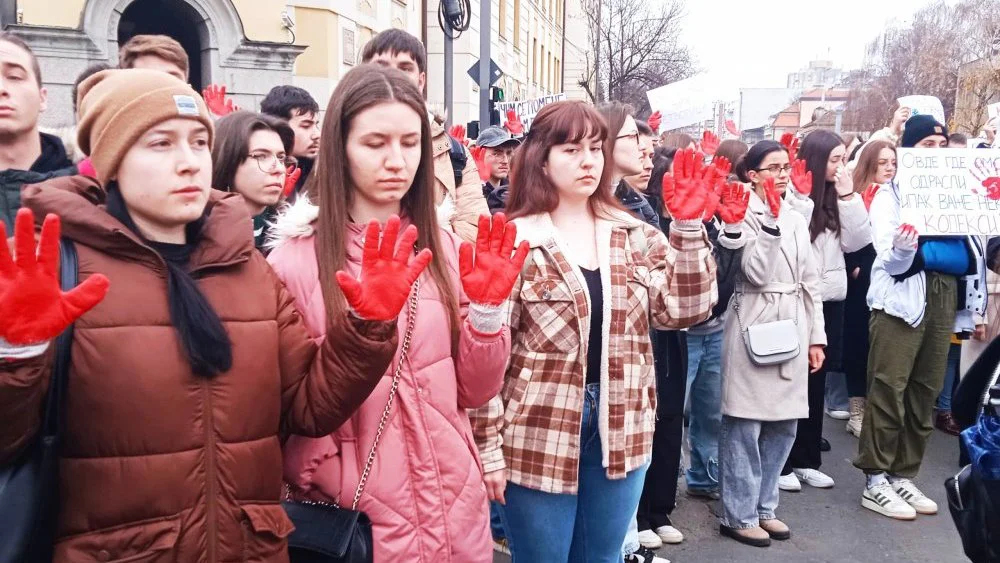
top-left (347, 102), bottom-right (422, 208)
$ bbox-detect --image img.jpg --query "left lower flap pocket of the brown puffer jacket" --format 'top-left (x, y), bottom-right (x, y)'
top-left (54, 514), bottom-right (181, 563)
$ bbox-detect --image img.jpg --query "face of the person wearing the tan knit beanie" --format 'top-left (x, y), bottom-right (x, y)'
top-left (114, 118), bottom-right (212, 240)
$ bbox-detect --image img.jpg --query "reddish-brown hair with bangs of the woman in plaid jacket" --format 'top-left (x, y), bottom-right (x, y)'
top-left (505, 101), bottom-right (621, 218)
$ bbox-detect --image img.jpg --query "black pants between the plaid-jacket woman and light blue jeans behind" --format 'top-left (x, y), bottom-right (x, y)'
top-left (636, 330), bottom-right (687, 532)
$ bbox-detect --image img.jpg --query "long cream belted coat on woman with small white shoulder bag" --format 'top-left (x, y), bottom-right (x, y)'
top-left (722, 193), bottom-right (826, 421)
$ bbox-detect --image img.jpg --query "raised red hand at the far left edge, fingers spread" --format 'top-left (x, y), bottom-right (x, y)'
top-left (0, 207), bottom-right (109, 346)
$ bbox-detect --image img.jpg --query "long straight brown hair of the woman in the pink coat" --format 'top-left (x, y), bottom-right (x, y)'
top-left (307, 64), bottom-right (459, 351)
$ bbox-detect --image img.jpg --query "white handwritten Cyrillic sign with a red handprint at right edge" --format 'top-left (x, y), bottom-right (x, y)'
top-left (896, 148), bottom-right (1000, 236)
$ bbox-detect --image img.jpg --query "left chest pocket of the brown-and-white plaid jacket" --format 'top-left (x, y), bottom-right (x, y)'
top-left (520, 279), bottom-right (580, 354)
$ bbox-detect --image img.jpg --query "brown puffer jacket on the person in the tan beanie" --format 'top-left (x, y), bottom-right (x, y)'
top-left (0, 176), bottom-right (397, 563)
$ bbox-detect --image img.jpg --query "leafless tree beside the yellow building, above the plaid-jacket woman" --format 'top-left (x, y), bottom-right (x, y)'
top-left (580, 0), bottom-right (694, 115)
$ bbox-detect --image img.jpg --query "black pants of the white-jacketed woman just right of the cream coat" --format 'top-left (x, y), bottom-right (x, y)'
top-left (781, 301), bottom-right (844, 475)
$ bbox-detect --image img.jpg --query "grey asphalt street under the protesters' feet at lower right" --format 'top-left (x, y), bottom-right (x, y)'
top-left (494, 417), bottom-right (968, 563)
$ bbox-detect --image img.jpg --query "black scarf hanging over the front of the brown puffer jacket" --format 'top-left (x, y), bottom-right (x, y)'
top-left (107, 183), bottom-right (233, 378)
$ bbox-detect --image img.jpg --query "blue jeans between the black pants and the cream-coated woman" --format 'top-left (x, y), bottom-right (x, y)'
top-left (685, 330), bottom-right (722, 490)
